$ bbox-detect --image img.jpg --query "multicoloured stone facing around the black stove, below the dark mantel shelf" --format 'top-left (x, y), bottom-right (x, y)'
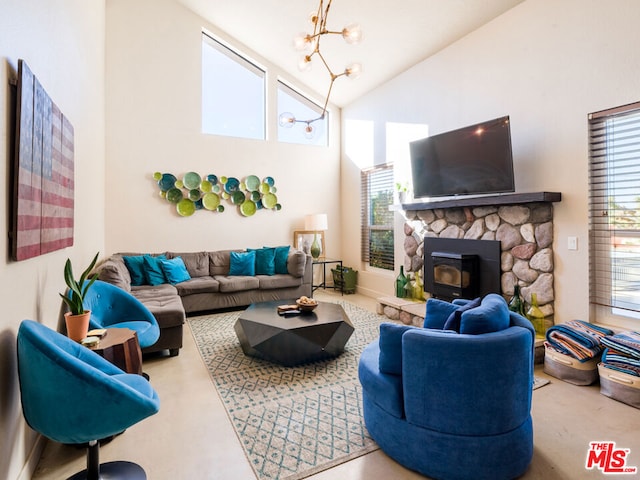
top-left (404, 202), bottom-right (554, 326)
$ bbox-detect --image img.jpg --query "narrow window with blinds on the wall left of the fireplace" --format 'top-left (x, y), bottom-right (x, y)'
top-left (360, 165), bottom-right (394, 270)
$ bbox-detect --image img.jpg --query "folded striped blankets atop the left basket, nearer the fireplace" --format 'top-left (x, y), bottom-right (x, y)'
top-left (544, 320), bottom-right (613, 362)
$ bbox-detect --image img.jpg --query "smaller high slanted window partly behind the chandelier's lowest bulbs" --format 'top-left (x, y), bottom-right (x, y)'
top-left (278, 80), bottom-right (329, 146)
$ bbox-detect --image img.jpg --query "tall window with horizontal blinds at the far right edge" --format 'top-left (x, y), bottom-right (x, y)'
top-left (589, 103), bottom-right (640, 321)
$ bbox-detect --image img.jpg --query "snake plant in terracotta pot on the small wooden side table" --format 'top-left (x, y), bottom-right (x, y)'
top-left (60, 252), bottom-right (99, 342)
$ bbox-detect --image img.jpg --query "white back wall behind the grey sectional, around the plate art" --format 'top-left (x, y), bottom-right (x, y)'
top-left (106, 0), bottom-right (340, 255)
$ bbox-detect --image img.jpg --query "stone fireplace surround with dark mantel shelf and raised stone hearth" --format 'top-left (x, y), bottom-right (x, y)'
top-left (379, 192), bottom-right (562, 326)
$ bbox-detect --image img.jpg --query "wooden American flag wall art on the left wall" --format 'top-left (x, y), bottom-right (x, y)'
top-left (10, 60), bottom-right (74, 260)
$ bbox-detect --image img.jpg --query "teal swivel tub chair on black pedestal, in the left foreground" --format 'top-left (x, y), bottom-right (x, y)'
top-left (17, 320), bottom-right (160, 480)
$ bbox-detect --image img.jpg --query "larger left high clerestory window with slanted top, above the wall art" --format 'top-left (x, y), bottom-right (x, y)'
top-left (202, 32), bottom-right (266, 140)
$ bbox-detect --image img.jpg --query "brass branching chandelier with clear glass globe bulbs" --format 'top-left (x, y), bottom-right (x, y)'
top-left (278, 0), bottom-right (362, 138)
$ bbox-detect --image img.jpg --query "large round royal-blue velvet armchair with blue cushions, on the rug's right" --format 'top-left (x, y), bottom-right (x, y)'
top-left (359, 295), bottom-right (535, 480)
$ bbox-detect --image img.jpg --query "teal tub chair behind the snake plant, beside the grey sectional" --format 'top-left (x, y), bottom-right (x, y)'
top-left (84, 280), bottom-right (160, 349)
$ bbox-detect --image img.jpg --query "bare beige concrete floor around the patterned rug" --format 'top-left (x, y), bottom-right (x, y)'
top-left (33, 290), bottom-right (640, 480)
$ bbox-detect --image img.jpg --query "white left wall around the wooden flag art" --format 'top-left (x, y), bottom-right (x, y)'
top-left (0, 0), bottom-right (105, 479)
